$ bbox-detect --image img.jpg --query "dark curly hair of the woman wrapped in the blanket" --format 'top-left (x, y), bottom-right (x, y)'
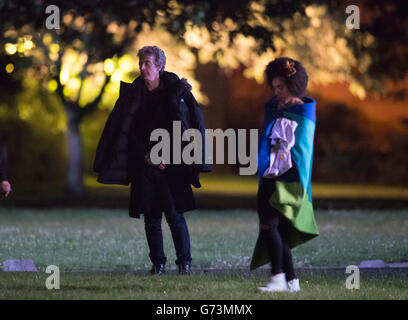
top-left (265, 57), bottom-right (308, 97)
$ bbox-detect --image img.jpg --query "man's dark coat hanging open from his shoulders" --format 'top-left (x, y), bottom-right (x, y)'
top-left (94, 71), bottom-right (212, 218)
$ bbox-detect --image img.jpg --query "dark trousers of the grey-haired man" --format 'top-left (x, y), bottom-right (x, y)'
top-left (141, 165), bottom-right (191, 265)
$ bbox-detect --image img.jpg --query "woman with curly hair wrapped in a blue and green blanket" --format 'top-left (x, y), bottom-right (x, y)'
top-left (251, 58), bottom-right (319, 292)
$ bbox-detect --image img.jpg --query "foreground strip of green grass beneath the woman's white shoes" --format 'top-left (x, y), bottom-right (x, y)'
top-left (0, 272), bottom-right (408, 300)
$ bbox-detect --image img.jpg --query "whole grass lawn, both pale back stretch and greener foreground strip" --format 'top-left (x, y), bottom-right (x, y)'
top-left (0, 207), bottom-right (408, 299)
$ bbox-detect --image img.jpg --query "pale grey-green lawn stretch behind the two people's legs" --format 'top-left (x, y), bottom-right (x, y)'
top-left (0, 207), bottom-right (408, 272)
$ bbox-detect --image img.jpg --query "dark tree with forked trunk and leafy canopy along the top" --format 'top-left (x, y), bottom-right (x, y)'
top-left (0, 0), bottom-right (408, 194)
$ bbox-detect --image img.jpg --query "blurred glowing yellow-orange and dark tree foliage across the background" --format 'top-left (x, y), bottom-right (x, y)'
top-left (0, 0), bottom-right (408, 190)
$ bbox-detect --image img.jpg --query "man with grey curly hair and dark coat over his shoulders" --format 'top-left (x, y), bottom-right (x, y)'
top-left (94, 46), bottom-right (212, 274)
